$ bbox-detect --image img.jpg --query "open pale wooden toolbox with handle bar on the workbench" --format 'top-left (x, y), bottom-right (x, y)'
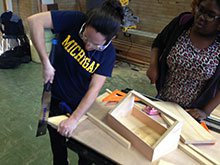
top-left (107, 91), bottom-right (183, 161)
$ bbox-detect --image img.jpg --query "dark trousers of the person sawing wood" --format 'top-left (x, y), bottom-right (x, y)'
top-left (48, 99), bottom-right (92, 165)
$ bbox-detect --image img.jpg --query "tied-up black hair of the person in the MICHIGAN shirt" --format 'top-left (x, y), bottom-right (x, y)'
top-left (86, 0), bottom-right (124, 41)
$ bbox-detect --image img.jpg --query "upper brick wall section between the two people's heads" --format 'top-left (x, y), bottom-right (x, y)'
top-left (129, 0), bottom-right (192, 33)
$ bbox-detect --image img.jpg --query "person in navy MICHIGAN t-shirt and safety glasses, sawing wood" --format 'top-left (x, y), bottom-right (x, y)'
top-left (28, 0), bottom-right (123, 165)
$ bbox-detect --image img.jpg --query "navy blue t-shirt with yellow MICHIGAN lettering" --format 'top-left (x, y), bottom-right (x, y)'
top-left (51, 11), bottom-right (116, 106)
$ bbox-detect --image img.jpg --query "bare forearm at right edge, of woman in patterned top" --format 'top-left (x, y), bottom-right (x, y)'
top-left (203, 91), bottom-right (220, 115)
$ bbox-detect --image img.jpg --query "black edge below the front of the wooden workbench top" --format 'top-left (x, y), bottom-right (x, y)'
top-left (66, 139), bottom-right (117, 165)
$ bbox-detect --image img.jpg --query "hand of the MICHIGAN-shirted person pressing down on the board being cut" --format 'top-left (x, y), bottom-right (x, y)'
top-left (57, 118), bottom-right (78, 137)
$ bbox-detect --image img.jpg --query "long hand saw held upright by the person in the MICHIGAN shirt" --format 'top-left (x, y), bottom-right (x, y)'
top-left (36, 39), bottom-right (57, 137)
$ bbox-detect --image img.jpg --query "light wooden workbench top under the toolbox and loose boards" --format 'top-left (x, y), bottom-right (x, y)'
top-left (49, 94), bottom-right (220, 165)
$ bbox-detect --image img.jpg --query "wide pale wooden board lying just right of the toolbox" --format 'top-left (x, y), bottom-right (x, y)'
top-left (158, 102), bottom-right (215, 144)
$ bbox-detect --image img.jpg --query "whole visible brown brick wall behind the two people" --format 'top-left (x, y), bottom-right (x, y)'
top-left (10, 0), bottom-right (192, 66)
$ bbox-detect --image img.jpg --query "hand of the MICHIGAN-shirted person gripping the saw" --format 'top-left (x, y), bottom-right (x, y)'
top-left (43, 61), bottom-right (55, 83)
